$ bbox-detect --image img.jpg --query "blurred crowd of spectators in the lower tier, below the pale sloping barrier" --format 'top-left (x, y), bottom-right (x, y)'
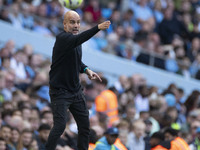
top-left (0, 40), bottom-right (200, 150)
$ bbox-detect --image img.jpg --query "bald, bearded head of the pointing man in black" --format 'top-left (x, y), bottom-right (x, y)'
top-left (63, 10), bottom-right (80, 34)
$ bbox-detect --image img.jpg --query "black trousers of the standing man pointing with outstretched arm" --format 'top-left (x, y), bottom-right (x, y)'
top-left (46, 88), bottom-right (90, 150)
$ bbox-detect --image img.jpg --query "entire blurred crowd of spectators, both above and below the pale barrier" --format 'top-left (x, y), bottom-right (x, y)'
top-left (0, 0), bottom-right (200, 150)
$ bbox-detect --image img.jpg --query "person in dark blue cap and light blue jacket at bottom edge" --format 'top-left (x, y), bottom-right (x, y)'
top-left (94, 127), bottom-right (119, 150)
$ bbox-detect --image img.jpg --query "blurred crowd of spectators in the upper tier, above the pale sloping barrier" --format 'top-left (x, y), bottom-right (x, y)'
top-left (0, 0), bottom-right (200, 79)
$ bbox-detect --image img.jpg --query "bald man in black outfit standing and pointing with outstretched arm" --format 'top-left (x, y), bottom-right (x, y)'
top-left (46, 11), bottom-right (110, 150)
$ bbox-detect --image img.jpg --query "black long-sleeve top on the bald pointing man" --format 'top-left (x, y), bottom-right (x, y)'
top-left (49, 26), bottom-right (99, 93)
